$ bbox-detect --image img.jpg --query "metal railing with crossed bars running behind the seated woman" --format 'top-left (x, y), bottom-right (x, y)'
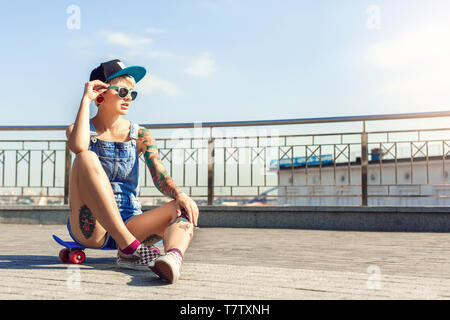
top-left (0, 111), bottom-right (450, 206)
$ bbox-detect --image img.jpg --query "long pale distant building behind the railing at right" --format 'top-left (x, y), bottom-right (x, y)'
top-left (271, 154), bottom-right (450, 206)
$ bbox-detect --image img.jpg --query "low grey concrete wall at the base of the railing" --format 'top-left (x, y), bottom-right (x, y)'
top-left (0, 206), bottom-right (450, 232)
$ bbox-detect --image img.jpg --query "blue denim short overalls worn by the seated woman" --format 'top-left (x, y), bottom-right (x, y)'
top-left (67, 119), bottom-right (142, 248)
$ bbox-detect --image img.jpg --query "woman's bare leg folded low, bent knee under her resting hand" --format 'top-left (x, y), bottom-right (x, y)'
top-left (126, 200), bottom-right (194, 254)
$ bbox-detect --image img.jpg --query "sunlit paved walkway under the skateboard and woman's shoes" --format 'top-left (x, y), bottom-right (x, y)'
top-left (0, 224), bottom-right (450, 300)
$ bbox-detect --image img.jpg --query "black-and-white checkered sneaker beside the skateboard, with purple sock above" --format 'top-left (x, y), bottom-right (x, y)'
top-left (117, 244), bottom-right (161, 270)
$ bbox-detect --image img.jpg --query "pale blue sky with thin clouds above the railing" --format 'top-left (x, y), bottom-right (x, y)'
top-left (0, 0), bottom-right (450, 130)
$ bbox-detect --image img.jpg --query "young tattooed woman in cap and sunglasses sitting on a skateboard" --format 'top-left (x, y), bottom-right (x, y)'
top-left (66, 60), bottom-right (199, 283)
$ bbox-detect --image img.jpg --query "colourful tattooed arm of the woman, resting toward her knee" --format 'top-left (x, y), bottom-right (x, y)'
top-left (138, 127), bottom-right (181, 199)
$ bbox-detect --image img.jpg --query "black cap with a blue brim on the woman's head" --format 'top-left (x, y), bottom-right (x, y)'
top-left (89, 59), bottom-right (147, 83)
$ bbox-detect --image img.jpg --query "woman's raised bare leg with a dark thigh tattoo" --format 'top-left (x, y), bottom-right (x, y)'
top-left (69, 150), bottom-right (135, 249)
